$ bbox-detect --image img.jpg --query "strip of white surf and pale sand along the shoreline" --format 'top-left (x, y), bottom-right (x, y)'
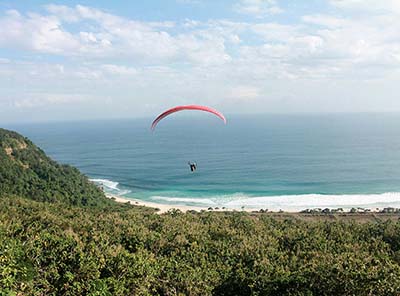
top-left (91, 179), bottom-right (400, 214)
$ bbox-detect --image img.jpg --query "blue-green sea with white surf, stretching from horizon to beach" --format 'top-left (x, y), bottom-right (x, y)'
top-left (5, 112), bottom-right (400, 210)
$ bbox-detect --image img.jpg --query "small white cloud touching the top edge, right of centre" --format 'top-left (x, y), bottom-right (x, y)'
top-left (234, 0), bottom-right (283, 18)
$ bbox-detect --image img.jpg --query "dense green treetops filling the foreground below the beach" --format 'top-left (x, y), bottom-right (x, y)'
top-left (0, 197), bottom-right (400, 295)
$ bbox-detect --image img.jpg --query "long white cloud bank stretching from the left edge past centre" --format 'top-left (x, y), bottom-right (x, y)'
top-left (0, 5), bottom-right (229, 64)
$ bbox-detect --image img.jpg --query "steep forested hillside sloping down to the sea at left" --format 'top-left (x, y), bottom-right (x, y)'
top-left (0, 129), bottom-right (106, 205)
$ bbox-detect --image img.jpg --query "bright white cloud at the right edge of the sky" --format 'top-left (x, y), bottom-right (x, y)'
top-left (302, 9), bottom-right (400, 70)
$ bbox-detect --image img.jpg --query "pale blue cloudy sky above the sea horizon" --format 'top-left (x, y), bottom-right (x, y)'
top-left (0, 0), bottom-right (400, 123)
